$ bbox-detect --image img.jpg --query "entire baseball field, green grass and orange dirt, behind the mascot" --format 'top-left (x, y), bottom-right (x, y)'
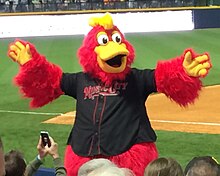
top-left (0, 29), bottom-right (220, 167)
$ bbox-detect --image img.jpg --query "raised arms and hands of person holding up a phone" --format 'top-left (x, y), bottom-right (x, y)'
top-left (26, 132), bottom-right (66, 176)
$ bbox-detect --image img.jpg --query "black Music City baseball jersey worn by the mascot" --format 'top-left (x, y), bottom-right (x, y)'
top-left (61, 68), bottom-right (156, 156)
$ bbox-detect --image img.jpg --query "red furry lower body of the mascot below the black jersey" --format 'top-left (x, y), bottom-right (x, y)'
top-left (64, 143), bottom-right (158, 176)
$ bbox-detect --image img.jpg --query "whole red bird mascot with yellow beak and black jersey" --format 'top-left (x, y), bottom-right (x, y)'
top-left (8, 13), bottom-right (211, 176)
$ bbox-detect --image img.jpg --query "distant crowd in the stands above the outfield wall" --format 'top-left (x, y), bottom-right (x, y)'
top-left (0, 0), bottom-right (217, 13)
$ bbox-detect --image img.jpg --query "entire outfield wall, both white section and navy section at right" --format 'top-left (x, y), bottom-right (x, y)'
top-left (0, 7), bottom-right (220, 38)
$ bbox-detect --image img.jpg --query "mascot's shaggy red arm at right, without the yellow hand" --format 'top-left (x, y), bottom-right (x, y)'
top-left (155, 49), bottom-right (205, 106)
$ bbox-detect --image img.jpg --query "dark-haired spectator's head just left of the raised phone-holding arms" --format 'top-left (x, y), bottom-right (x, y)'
top-left (5, 150), bottom-right (26, 176)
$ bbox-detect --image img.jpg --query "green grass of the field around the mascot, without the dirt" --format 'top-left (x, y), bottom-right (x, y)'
top-left (0, 29), bottom-right (220, 170)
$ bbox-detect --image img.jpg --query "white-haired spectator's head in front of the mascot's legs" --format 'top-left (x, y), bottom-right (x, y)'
top-left (78, 158), bottom-right (133, 176)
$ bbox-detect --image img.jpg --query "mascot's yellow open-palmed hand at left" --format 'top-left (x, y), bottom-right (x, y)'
top-left (8, 41), bottom-right (32, 65)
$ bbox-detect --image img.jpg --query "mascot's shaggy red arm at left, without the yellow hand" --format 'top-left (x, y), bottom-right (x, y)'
top-left (14, 43), bottom-right (63, 108)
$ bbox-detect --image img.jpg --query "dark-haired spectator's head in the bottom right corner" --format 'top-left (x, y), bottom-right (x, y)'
top-left (184, 156), bottom-right (220, 176)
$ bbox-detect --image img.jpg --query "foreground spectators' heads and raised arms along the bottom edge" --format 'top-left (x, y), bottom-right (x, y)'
top-left (0, 134), bottom-right (220, 176)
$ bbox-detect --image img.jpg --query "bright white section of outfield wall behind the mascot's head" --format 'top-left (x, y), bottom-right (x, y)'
top-left (0, 10), bottom-right (194, 38)
